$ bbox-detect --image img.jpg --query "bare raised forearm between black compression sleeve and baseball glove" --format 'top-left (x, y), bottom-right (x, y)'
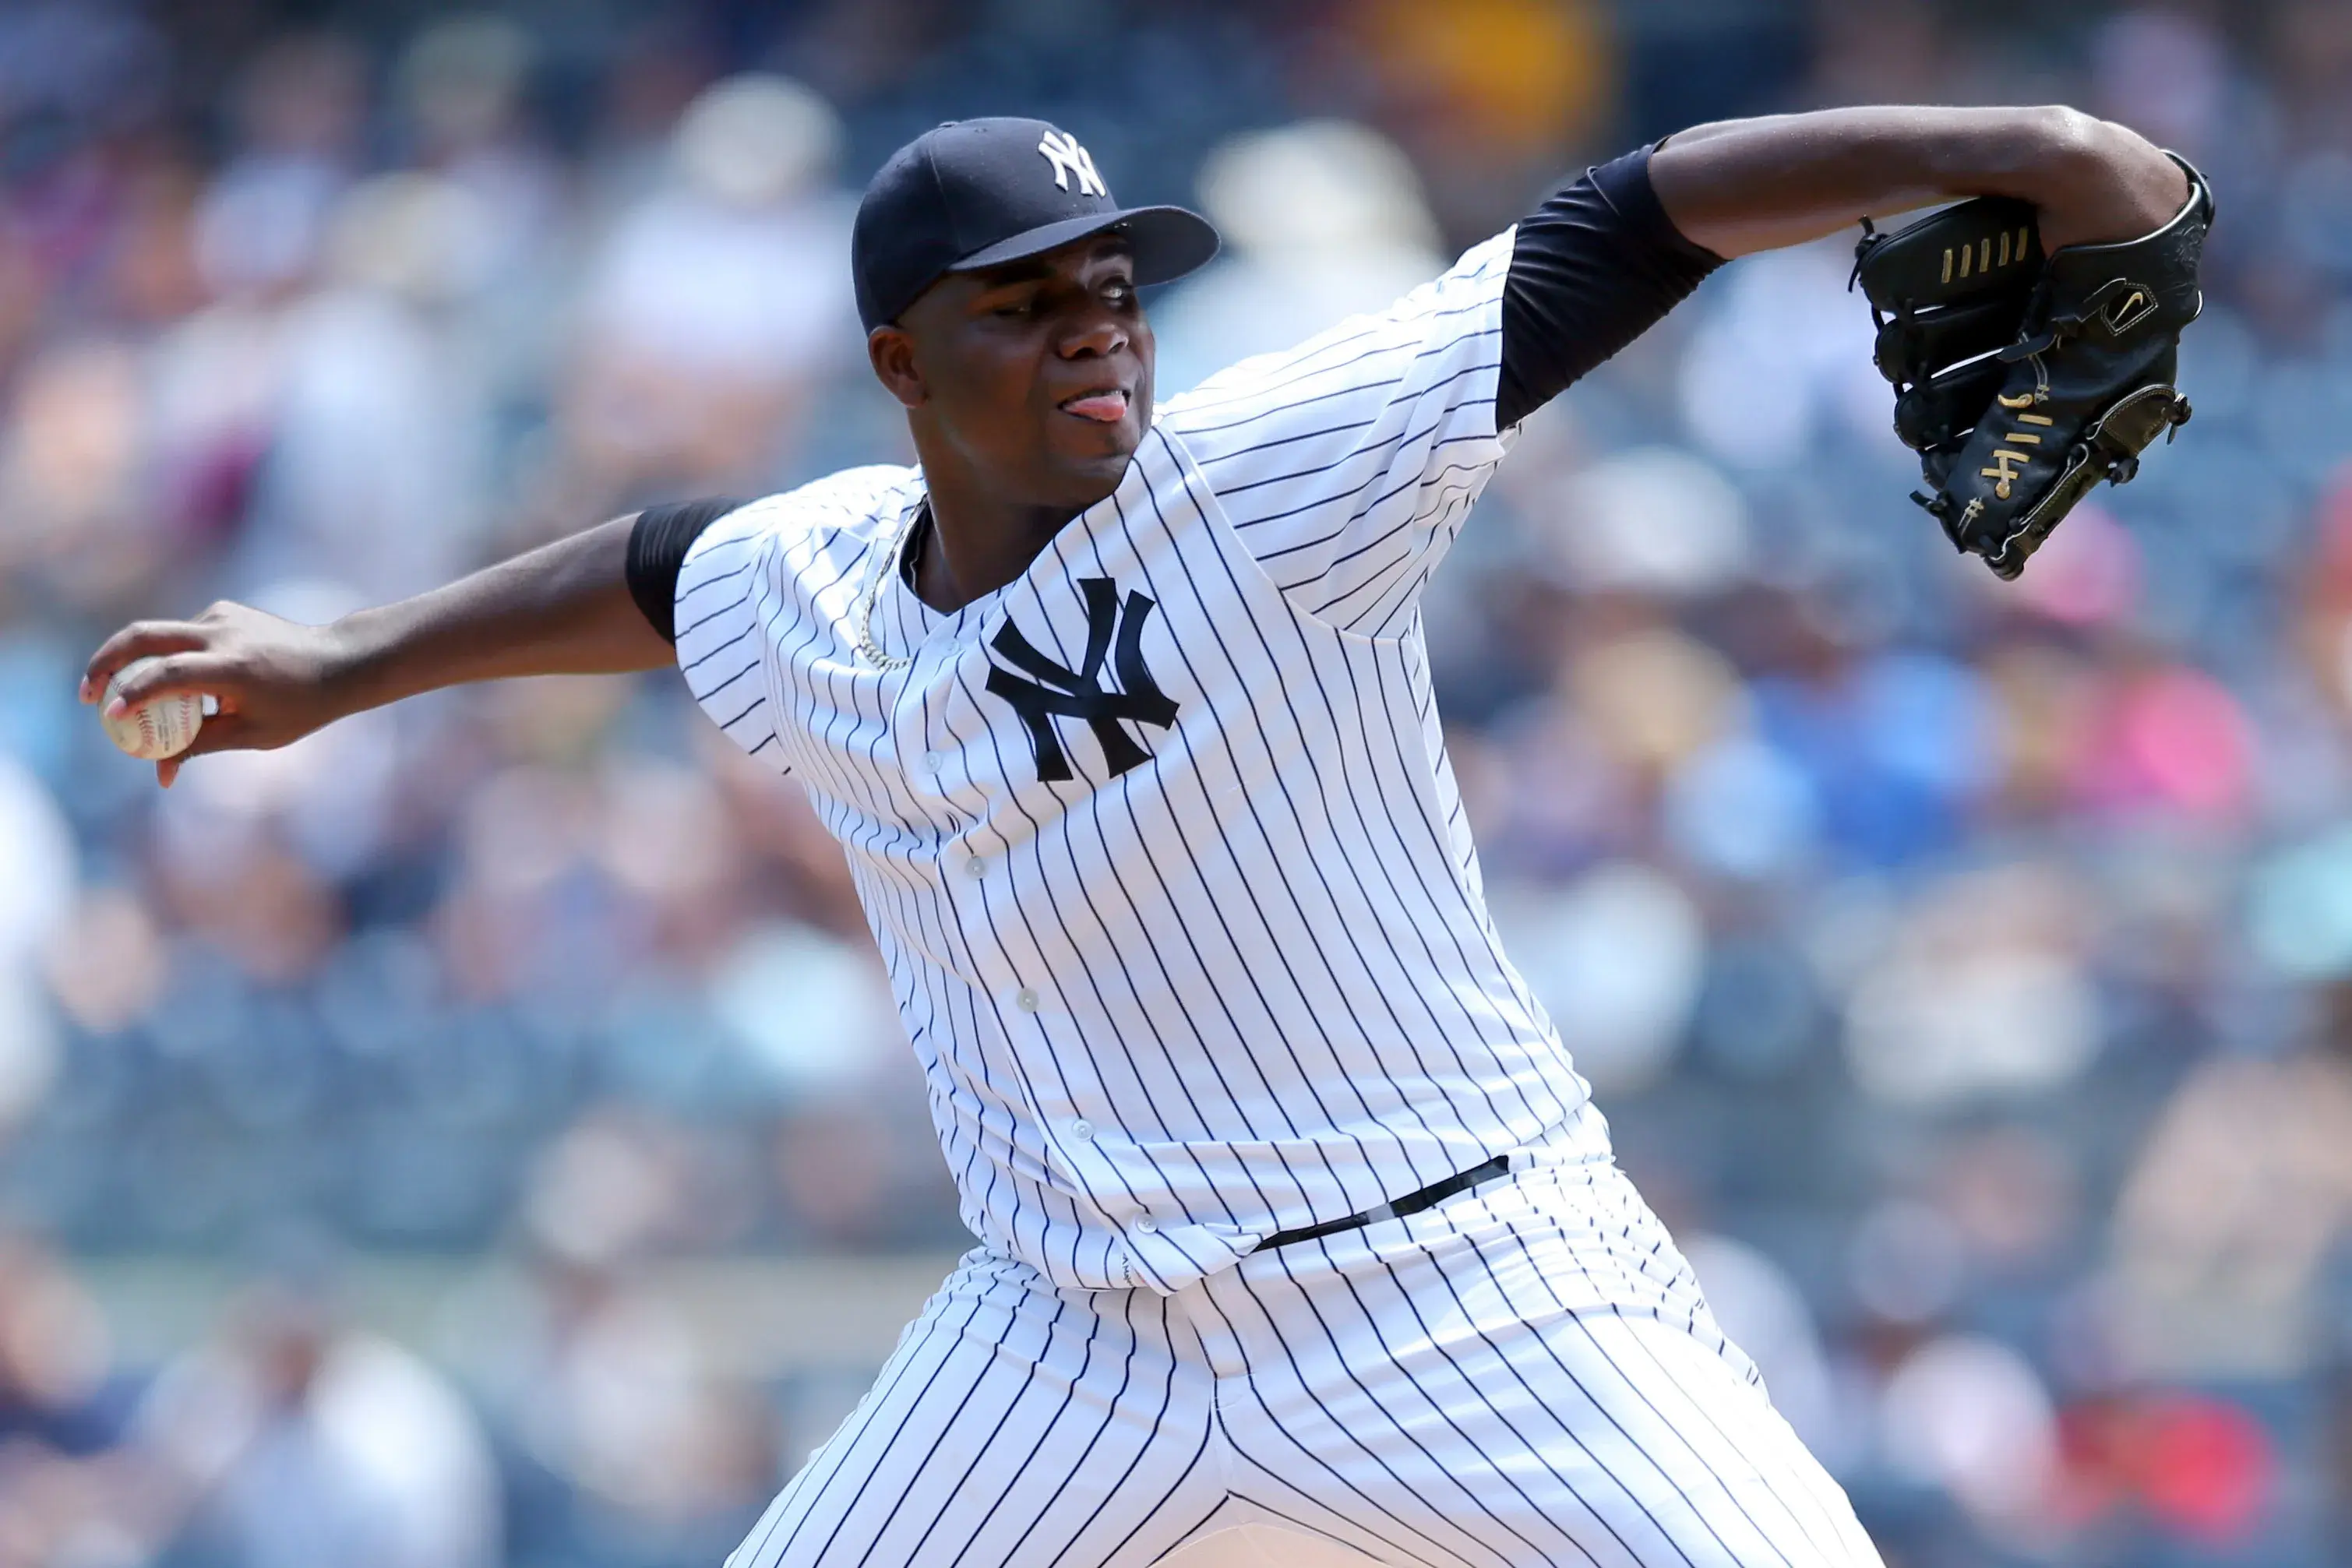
top-left (1651, 106), bottom-right (2188, 256)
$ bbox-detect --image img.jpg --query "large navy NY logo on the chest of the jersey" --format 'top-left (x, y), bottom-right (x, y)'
top-left (988, 576), bottom-right (1176, 783)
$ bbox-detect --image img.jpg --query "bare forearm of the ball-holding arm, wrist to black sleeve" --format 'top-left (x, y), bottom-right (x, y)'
top-left (330, 517), bottom-right (675, 712)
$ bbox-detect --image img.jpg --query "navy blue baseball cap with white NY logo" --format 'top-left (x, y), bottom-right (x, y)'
top-left (849, 118), bottom-right (1216, 332)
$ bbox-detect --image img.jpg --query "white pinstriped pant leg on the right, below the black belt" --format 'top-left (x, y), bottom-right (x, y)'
top-left (1202, 1147), bottom-right (1877, 1568)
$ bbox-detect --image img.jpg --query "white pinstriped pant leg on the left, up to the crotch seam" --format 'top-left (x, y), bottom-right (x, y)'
top-left (727, 1253), bottom-right (1223, 1568)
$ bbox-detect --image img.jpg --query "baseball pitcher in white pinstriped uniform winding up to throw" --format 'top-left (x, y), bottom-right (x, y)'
top-left (83, 108), bottom-right (2211, 1568)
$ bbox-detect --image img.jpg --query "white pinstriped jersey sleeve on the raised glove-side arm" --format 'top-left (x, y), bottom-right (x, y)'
top-left (1162, 231), bottom-right (1512, 635)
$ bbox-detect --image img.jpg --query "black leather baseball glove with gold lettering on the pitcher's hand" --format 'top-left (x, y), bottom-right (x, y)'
top-left (1853, 155), bottom-right (2213, 578)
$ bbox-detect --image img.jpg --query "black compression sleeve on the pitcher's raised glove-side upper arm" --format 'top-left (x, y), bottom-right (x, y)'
top-left (1493, 148), bottom-right (1724, 430)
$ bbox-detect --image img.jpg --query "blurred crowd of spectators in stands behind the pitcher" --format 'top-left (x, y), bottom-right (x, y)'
top-left (0, 0), bottom-right (2352, 1568)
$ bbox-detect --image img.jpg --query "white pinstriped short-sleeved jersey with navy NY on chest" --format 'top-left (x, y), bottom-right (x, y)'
top-left (677, 233), bottom-right (1588, 1293)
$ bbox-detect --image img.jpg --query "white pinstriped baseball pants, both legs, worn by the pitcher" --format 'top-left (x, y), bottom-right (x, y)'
top-left (727, 1117), bottom-right (1879, 1568)
